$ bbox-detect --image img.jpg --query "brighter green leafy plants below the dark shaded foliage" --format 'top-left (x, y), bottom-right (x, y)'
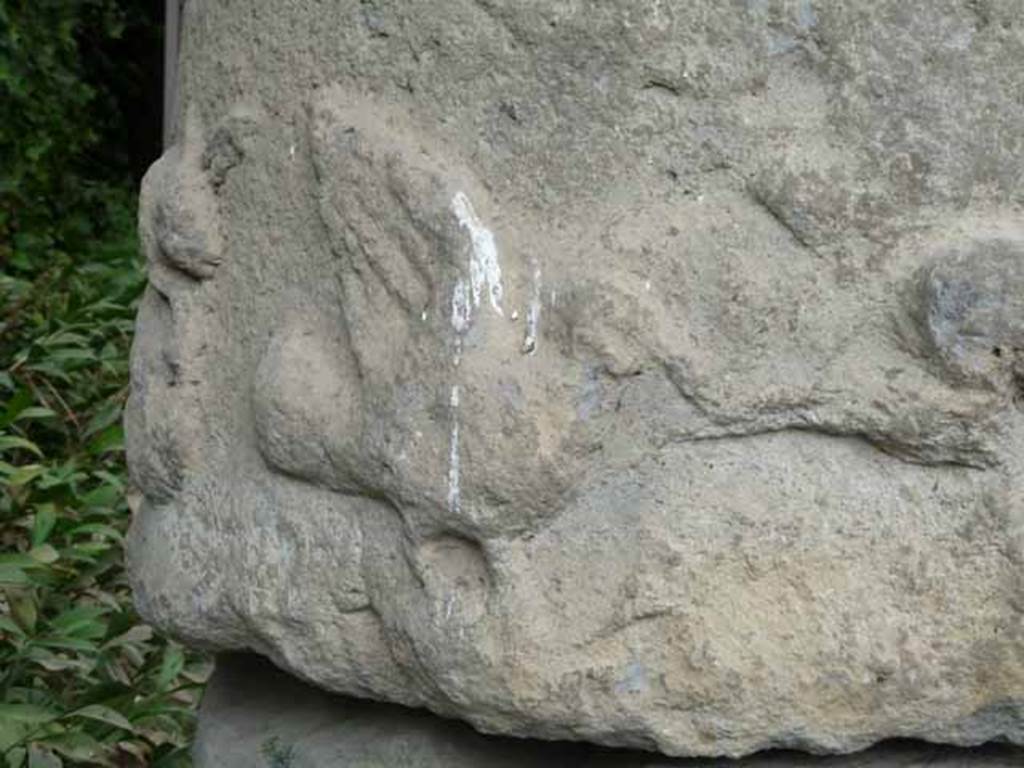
top-left (0, 191), bottom-right (206, 766)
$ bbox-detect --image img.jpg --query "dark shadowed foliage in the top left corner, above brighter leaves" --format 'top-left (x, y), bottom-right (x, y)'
top-left (0, 0), bottom-right (130, 269)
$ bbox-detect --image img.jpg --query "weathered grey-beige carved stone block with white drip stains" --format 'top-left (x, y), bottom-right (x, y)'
top-left (127, 0), bottom-right (1024, 756)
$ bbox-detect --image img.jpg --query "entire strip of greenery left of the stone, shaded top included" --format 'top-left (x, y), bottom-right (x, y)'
top-left (0, 0), bottom-right (207, 768)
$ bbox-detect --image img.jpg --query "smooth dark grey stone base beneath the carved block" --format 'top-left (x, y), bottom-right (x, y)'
top-left (195, 655), bottom-right (1024, 768)
